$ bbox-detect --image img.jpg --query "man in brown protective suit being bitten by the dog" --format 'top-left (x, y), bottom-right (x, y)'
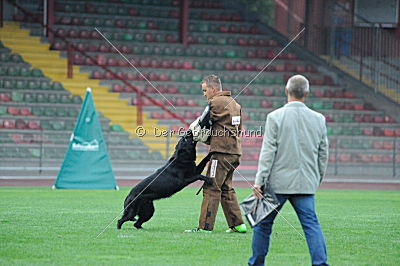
top-left (185, 75), bottom-right (247, 233)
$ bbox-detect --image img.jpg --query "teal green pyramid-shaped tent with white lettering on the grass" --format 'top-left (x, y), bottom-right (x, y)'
top-left (53, 88), bottom-right (118, 189)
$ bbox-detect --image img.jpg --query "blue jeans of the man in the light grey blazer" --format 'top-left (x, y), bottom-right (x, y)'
top-left (249, 194), bottom-right (328, 265)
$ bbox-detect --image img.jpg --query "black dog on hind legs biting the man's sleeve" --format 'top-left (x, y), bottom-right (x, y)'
top-left (117, 131), bottom-right (213, 229)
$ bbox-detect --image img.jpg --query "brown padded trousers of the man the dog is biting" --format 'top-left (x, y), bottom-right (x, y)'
top-left (199, 153), bottom-right (243, 231)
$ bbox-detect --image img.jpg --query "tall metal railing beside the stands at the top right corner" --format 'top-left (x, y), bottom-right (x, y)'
top-left (248, 0), bottom-right (400, 103)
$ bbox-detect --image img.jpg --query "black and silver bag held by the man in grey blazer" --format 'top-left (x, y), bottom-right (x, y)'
top-left (240, 186), bottom-right (279, 227)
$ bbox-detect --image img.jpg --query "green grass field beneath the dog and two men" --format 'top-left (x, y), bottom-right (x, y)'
top-left (0, 187), bottom-right (400, 265)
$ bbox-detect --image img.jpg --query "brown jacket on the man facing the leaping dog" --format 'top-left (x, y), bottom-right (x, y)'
top-left (208, 91), bottom-right (242, 155)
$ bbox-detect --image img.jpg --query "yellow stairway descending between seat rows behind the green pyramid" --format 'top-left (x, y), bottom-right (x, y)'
top-left (0, 22), bottom-right (168, 157)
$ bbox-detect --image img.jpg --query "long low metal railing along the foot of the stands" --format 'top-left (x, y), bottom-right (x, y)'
top-left (0, 127), bottom-right (400, 180)
